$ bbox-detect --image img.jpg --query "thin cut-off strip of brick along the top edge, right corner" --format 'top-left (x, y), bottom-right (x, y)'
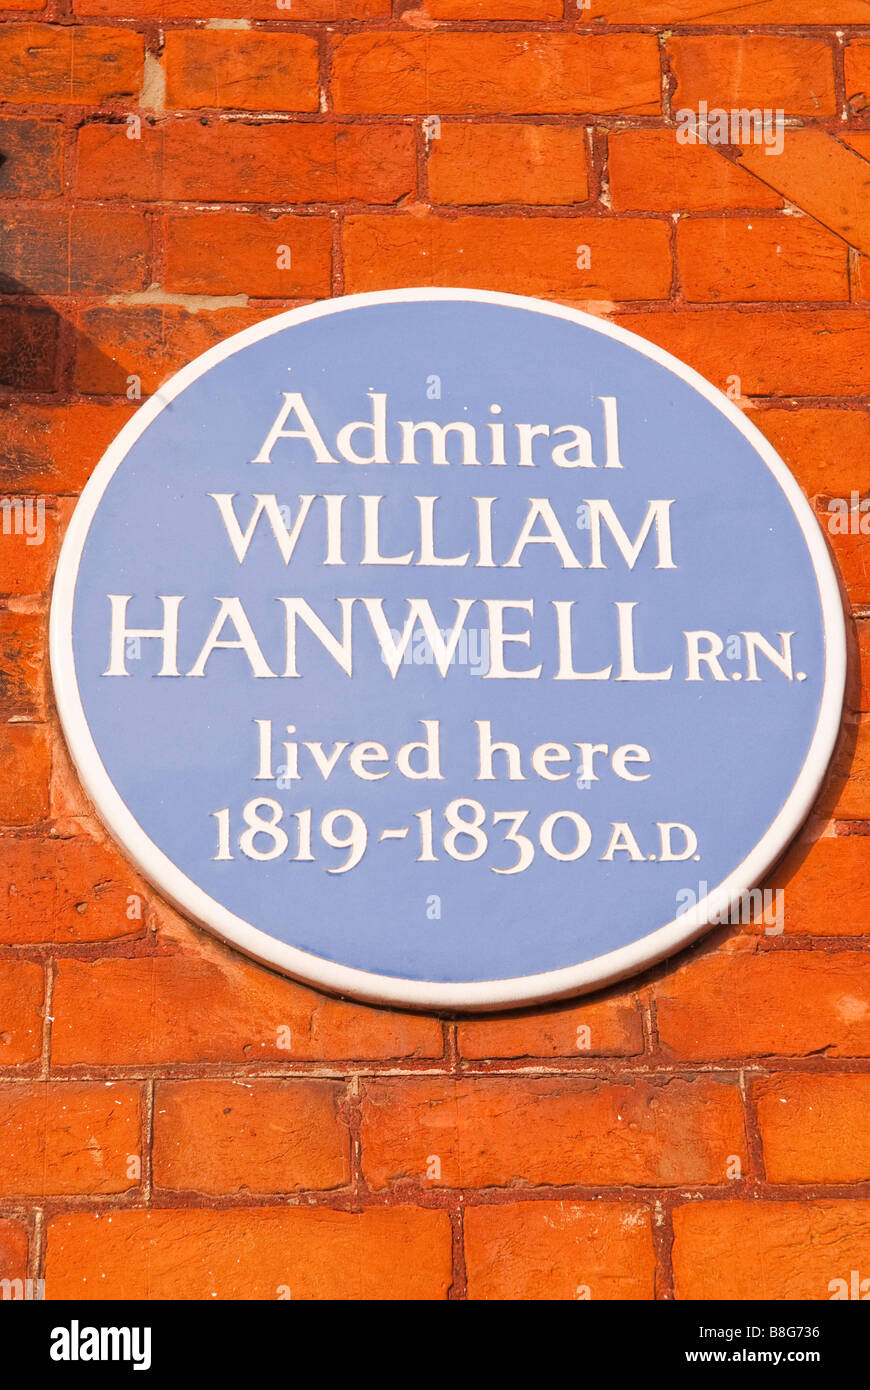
top-left (595, 0), bottom-right (867, 18)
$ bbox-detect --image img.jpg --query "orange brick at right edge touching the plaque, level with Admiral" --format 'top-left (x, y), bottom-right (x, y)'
top-left (750, 407), bottom-right (870, 498)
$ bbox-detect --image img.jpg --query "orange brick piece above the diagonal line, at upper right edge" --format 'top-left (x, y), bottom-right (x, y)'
top-left (739, 134), bottom-right (870, 252)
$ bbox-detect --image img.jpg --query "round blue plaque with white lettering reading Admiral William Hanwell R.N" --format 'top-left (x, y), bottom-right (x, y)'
top-left (51, 289), bottom-right (845, 1009)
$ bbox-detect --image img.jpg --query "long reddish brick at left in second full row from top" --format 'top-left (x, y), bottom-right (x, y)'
top-left (76, 120), bottom-right (417, 206)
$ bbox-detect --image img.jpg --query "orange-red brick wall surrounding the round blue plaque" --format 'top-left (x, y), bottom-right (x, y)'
top-left (0, 0), bottom-right (870, 1300)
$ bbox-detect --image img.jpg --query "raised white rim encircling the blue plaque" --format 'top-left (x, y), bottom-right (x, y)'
top-left (50, 288), bottom-right (846, 1011)
